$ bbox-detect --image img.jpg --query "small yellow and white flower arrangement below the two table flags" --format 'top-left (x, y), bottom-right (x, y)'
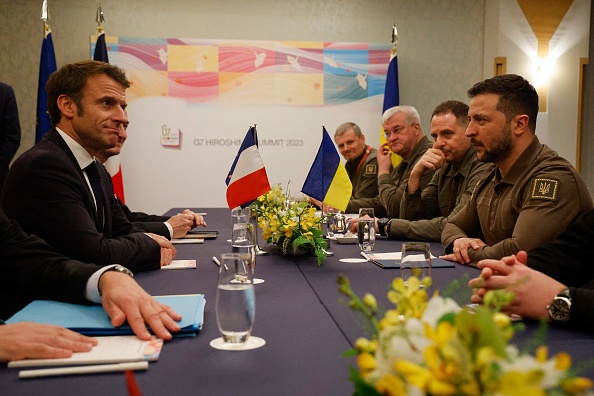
top-left (252, 184), bottom-right (327, 265)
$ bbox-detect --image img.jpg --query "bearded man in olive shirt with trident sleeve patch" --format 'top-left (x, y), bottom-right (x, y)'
top-left (441, 74), bottom-right (592, 264)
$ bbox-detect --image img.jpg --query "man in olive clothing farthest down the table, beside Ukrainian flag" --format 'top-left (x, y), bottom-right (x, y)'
top-left (334, 122), bottom-right (378, 199)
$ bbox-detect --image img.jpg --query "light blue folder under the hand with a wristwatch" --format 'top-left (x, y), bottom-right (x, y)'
top-left (6, 294), bottom-right (205, 337)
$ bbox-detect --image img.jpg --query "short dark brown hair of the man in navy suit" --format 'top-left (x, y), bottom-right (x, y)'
top-left (45, 61), bottom-right (130, 127)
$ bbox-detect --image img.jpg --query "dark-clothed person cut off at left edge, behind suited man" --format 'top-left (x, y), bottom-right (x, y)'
top-left (0, 82), bottom-right (21, 191)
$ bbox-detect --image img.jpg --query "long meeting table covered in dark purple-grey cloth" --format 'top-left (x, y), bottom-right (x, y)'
top-left (0, 208), bottom-right (594, 395)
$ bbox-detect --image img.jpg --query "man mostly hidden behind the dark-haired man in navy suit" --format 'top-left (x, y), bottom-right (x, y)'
top-left (95, 123), bottom-right (206, 239)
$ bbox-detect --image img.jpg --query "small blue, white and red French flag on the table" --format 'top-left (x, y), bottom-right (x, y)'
top-left (225, 126), bottom-right (270, 209)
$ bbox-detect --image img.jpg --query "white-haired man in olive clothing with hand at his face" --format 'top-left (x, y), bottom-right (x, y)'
top-left (345, 106), bottom-right (433, 217)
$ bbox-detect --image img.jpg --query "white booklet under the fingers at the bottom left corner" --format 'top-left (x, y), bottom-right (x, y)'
top-left (8, 336), bottom-right (163, 367)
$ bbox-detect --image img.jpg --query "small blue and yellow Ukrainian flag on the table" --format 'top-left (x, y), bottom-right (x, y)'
top-left (301, 128), bottom-right (353, 211)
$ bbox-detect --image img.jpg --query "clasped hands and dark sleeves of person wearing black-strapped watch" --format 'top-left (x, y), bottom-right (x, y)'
top-left (469, 210), bottom-right (594, 332)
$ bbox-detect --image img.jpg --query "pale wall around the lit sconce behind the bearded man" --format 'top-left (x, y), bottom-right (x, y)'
top-left (483, 0), bottom-right (590, 165)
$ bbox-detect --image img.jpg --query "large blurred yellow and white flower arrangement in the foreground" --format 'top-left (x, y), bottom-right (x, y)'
top-left (338, 277), bottom-right (593, 395)
